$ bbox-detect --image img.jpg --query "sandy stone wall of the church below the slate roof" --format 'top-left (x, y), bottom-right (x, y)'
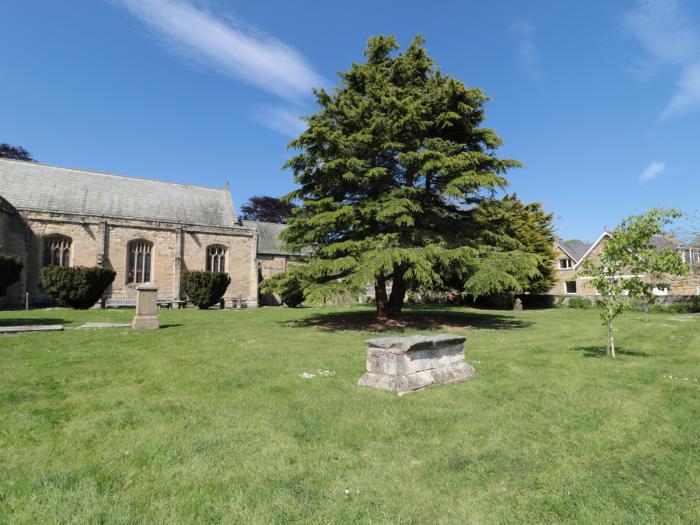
top-left (0, 212), bottom-right (258, 307)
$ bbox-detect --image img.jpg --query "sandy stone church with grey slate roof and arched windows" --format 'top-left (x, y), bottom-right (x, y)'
top-left (0, 159), bottom-right (259, 308)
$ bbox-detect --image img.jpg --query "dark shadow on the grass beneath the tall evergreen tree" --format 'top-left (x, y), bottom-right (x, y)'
top-left (281, 310), bottom-right (532, 332)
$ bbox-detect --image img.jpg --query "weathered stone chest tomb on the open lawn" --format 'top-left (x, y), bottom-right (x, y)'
top-left (358, 335), bottom-right (476, 395)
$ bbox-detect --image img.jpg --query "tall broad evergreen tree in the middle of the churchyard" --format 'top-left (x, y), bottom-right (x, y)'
top-left (283, 36), bottom-right (538, 317)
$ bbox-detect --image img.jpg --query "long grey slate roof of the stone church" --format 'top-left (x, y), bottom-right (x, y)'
top-left (0, 159), bottom-right (236, 227)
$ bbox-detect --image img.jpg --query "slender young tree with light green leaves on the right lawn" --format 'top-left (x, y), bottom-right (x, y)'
top-left (583, 208), bottom-right (688, 357)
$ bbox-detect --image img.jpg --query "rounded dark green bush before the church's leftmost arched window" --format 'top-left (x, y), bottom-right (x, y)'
top-left (41, 266), bottom-right (117, 310)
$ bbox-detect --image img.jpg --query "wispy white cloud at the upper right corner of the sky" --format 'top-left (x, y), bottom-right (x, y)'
top-left (623, 0), bottom-right (700, 120)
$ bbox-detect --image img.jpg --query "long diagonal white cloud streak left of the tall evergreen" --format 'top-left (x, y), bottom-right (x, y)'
top-left (113, 0), bottom-right (323, 101)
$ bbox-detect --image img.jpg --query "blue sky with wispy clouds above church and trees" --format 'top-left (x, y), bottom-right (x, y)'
top-left (0, 0), bottom-right (700, 240)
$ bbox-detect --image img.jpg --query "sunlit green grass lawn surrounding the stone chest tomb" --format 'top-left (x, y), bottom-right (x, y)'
top-left (0, 308), bottom-right (700, 524)
